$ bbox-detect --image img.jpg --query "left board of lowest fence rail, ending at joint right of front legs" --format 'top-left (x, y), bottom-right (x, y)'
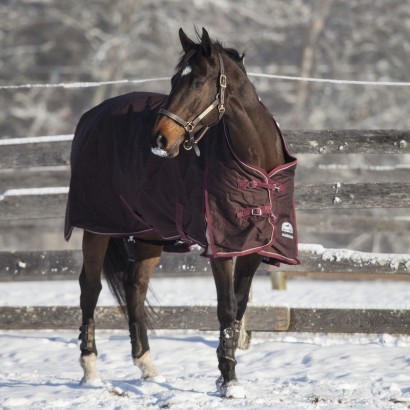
top-left (0, 306), bottom-right (290, 331)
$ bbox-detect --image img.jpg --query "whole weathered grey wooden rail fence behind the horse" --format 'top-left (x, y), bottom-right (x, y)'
top-left (0, 130), bottom-right (410, 334)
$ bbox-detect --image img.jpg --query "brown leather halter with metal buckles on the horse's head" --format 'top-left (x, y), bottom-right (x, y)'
top-left (158, 53), bottom-right (227, 157)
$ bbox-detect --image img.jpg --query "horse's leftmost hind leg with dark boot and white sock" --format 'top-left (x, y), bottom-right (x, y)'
top-left (79, 231), bottom-right (109, 385)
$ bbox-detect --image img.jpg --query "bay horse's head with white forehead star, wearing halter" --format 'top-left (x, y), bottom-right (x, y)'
top-left (152, 28), bottom-right (226, 158)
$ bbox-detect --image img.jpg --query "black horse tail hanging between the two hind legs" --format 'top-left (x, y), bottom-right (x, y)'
top-left (104, 238), bottom-right (133, 319)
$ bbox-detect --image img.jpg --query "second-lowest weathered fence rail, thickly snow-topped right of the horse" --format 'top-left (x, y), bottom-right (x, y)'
top-left (0, 244), bottom-right (410, 281)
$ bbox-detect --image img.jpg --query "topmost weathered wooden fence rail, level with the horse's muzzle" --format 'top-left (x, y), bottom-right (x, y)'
top-left (0, 130), bottom-right (410, 168)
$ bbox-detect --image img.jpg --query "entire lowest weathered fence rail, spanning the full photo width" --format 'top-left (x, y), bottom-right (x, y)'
top-left (0, 306), bottom-right (410, 334)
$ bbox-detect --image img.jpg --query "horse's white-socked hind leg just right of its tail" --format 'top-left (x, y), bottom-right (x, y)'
top-left (123, 242), bottom-right (165, 382)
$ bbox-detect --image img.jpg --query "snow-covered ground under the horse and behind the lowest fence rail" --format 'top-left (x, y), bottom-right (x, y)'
top-left (0, 277), bottom-right (410, 410)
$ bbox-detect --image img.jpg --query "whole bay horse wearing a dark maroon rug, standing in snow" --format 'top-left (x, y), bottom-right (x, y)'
top-left (65, 29), bottom-right (298, 398)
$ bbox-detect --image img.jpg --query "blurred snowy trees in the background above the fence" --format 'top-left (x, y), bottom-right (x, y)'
top-left (0, 0), bottom-right (410, 137)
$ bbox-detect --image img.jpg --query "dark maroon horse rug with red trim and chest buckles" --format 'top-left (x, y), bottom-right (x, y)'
top-left (65, 92), bottom-right (298, 265)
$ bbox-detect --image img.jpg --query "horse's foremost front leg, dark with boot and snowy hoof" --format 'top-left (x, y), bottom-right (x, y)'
top-left (211, 258), bottom-right (246, 398)
